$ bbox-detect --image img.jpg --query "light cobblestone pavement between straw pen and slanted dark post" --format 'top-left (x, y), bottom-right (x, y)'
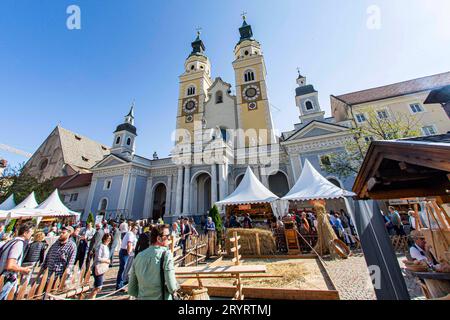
top-left (325, 252), bottom-right (376, 300)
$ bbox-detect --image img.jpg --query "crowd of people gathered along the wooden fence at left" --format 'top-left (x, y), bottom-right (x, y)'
top-left (0, 217), bottom-right (220, 299)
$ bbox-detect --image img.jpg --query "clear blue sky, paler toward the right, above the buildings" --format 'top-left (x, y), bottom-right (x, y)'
top-left (0, 0), bottom-right (450, 169)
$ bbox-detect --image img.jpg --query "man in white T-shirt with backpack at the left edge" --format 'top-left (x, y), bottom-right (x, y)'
top-left (0, 222), bottom-right (34, 300)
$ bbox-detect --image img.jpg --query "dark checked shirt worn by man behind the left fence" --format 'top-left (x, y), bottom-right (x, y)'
top-left (42, 239), bottom-right (77, 276)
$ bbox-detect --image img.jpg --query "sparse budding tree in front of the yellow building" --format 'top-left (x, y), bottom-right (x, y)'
top-left (321, 108), bottom-right (421, 178)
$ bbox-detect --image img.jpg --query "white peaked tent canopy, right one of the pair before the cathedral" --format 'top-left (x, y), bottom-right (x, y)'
top-left (282, 160), bottom-right (356, 201)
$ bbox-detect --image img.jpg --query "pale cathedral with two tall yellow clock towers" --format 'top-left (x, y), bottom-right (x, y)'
top-left (83, 17), bottom-right (352, 222)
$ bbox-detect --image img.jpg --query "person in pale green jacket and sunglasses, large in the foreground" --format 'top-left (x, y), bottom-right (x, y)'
top-left (128, 225), bottom-right (179, 300)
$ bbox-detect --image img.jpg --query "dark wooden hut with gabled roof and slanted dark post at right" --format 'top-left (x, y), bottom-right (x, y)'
top-left (353, 133), bottom-right (450, 299)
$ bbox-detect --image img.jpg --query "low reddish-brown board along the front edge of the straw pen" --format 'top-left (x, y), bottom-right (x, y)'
top-left (181, 284), bottom-right (339, 300)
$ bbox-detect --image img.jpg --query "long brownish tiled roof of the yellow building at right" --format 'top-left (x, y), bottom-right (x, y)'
top-left (337, 71), bottom-right (450, 105)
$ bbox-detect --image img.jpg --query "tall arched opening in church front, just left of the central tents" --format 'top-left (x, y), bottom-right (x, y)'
top-left (192, 172), bottom-right (212, 215)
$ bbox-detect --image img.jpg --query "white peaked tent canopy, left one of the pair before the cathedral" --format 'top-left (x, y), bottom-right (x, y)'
top-left (216, 167), bottom-right (278, 206)
